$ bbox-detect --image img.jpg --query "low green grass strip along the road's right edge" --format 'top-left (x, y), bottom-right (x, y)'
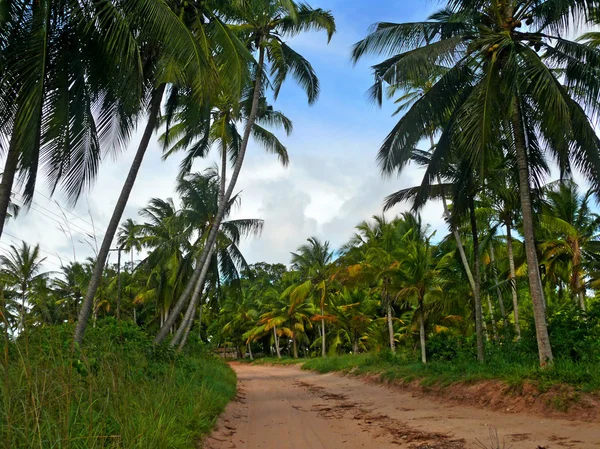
top-left (302, 352), bottom-right (600, 392)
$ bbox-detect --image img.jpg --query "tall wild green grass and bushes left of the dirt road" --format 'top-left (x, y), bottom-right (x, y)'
top-left (0, 323), bottom-right (236, 449)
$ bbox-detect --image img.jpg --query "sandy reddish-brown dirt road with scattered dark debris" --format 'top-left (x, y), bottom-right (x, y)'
top-left (204, 364), bottom-right (600, 449)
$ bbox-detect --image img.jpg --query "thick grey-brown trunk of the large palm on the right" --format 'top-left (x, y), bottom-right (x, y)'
top-left (512, 97), bottom-right (553, 366)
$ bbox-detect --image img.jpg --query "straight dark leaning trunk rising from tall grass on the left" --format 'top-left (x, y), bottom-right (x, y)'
top-left (74, 84), bottom-right (165, 344)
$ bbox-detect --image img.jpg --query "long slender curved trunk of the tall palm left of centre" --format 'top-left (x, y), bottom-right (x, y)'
top-left (154, 41), bottom-right (265, 344)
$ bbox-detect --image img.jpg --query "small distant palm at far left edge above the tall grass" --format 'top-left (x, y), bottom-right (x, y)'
top-left (0, 242), bottom-right (48, 331)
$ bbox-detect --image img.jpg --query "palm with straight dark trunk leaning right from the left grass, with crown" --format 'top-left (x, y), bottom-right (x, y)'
top-left (74, 0), bottom-right (247, 343)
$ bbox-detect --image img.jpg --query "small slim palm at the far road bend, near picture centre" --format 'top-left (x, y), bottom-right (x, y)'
top-left (292, 237), bottom-right (333, 357)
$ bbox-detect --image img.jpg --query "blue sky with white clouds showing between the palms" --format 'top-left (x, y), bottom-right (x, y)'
top-left (2, 0), bottom-right (445, 269)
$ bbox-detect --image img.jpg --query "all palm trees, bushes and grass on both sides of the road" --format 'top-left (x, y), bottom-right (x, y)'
top-left (0, 0), bottom-right (600, 448)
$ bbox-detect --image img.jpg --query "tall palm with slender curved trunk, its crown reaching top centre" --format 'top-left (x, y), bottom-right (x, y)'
top-left (154, 0), bottom-right (335, 344)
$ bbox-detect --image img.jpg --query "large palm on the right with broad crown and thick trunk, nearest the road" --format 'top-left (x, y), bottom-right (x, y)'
top-left (353, 0), bottom-right (600, 366)
